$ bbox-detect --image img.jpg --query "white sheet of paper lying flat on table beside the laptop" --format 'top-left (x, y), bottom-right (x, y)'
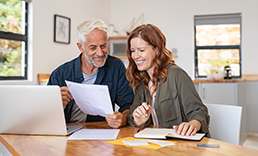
top-left (67, 129), bottom-right (120, 140)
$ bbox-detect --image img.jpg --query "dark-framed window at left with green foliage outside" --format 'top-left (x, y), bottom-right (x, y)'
top-left (0, 0), bottom-right (28, 80)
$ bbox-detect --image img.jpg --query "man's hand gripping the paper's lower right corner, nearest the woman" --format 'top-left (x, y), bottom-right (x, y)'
top-left (106, 109), bottom-right (130, 128)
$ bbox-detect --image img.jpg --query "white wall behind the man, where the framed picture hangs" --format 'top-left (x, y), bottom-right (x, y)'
top-left (0, 0), bottom-right (110, 84)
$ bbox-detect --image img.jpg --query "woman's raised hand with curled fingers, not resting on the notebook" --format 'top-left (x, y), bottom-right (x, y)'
top-left (133, 102), bottom-right (151, 126)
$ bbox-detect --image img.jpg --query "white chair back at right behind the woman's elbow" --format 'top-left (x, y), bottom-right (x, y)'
top-left (205, 104), bottom-right (242, 145)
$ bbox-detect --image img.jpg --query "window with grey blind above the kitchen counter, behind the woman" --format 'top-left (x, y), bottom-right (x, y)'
top-left (194, 14), bottom-right (241, 78)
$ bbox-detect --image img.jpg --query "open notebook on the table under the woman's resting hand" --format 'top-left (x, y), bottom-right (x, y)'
top-left (134, 128), bottom-right (205, 141)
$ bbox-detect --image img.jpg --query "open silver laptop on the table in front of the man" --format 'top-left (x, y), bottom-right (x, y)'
top-left (0, 85), bottom-right (83, 135)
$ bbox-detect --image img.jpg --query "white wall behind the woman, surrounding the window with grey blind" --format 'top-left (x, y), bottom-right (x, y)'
top-left (110, 0), bottom-right (258, 78)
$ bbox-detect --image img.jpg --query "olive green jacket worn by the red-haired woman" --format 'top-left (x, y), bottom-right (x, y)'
top-left (128, 65), bottom-right (210, 137)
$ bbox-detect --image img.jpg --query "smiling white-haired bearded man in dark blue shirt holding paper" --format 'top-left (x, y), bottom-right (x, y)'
top-left (48, 19), bottom-right (134, 128)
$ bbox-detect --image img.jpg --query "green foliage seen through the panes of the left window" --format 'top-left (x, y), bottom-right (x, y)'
top-left (0, 0), bottom-right (22, 76)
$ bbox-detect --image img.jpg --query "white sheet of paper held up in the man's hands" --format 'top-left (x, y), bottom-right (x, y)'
top-left (65, 81), bottom-right (114, 117)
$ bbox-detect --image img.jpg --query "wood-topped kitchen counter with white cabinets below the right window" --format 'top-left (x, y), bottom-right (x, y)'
top-left (193, 74), bottom-right (258, 133)
